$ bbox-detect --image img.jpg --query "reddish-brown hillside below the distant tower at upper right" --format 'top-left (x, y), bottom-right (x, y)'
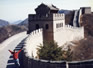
top-left (80, 13), bottom-right (93, 37)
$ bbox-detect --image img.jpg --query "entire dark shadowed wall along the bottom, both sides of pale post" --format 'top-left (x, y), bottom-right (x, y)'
top-left (23, 51), bottom-right (93, 68)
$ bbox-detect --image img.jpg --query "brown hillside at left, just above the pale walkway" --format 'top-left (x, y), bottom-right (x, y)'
top-left (0, 25), bottom-right (27, 43)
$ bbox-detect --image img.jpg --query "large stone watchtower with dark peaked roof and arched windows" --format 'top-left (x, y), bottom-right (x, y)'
top-left (28, 3), bottom-right (65, 41)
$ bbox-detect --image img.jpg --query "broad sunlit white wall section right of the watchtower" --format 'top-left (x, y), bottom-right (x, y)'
top-left (54, 25), bottom-right (84, 46)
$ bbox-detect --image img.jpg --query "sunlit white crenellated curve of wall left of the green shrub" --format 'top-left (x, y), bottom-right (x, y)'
top-left (24, 29), bottom-right (43, 58)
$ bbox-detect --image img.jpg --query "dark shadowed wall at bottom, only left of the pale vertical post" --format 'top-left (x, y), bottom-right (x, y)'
top-left (24, 56), bottom-right (67, 68)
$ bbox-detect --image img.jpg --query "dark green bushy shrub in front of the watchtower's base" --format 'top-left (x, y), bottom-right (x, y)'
top-left (37, 42), bottom-right (71, 61)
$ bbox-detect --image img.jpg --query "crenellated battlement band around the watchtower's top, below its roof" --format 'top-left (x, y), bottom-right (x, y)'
top-left (29, 13), bottom-right (65, 21)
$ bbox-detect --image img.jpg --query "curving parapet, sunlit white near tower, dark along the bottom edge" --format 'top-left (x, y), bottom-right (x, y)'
top-left (23, 29), bottom-right (93, 68)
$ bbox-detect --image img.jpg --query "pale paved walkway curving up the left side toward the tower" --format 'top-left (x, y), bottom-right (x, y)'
top-left (0, 32), bottom-right (27, 68)
